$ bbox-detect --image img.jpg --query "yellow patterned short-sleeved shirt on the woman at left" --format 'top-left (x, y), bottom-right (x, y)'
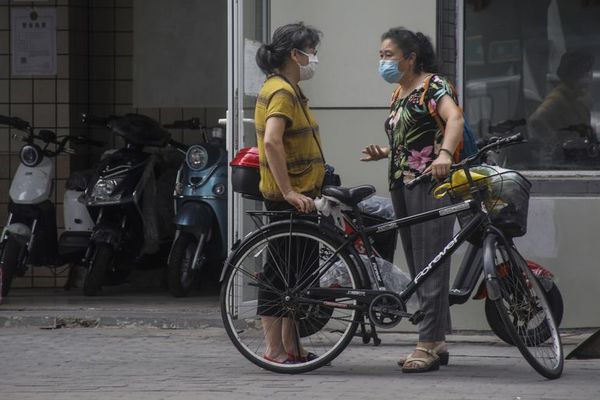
top-left (254, 76), bottom-right (325, 200)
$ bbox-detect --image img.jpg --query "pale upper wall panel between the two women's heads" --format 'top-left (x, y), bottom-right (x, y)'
top-left (271, 0), bottom-right (436, 108)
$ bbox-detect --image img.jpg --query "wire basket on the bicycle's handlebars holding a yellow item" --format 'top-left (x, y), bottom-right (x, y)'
top-left (448, 165), bottom-right (531, 237)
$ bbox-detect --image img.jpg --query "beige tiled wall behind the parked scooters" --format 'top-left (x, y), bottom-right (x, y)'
top-left (0, 0), bottom-right (225, 287)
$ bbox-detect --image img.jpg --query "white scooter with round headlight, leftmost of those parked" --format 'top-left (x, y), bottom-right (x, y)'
top-left (0, 116), bottom-right (104, 296)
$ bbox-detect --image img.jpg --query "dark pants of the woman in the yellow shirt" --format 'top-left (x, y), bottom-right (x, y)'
top-left (257, 201), bottom-right (319, 317)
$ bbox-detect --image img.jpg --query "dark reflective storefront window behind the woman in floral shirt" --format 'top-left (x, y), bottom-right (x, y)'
top-left (464, 0), bottom-right (600, 170)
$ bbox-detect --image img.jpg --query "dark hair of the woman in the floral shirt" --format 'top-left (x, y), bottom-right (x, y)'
top-left (381, 26), bottom-right (437, 73)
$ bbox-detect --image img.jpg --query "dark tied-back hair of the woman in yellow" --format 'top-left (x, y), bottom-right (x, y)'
top-left (256, 22), bottom-right (322, 74)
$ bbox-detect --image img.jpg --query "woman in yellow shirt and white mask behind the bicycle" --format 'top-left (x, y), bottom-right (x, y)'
top-left (255, 22), bottom-right (325, 363)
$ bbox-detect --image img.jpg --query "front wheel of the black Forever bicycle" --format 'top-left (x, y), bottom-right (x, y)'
top-left (484, 234), bottom-right (564, 379)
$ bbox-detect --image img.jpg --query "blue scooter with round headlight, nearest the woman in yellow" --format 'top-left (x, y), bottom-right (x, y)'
top-left (164, 118), bottom-right (227, 297)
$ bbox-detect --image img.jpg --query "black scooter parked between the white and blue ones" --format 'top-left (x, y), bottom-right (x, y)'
top-left (83, 114), bottom-right (187, 296)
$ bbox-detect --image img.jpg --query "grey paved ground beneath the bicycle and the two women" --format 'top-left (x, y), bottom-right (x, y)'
top-left (0, 289), bottom-right (600, 400)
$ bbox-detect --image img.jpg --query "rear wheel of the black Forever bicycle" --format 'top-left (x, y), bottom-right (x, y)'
top-left (221, 220), bottom-right (362, 373)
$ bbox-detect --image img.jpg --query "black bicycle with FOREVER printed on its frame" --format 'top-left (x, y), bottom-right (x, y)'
top-left (220, 134), bottom-right (564, 379)
